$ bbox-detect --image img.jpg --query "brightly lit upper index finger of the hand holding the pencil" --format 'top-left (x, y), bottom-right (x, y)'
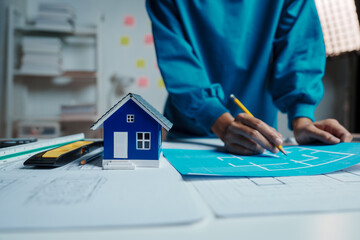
top-left (235, 114), bottom-right (282, 150)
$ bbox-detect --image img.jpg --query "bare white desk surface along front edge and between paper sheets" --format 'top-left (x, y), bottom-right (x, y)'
top-left (0, 138), bottom-right (360, 240)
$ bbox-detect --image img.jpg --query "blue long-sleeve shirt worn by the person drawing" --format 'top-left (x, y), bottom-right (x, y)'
top-left (146, 0), bottom-right (326, 136)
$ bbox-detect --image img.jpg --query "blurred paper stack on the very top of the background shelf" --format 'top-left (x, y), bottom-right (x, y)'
top-left (35, 3), bottom-right (76, 31)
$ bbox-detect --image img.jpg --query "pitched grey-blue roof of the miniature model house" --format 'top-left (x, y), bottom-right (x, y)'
top-left (91, 93), bottom-right (173, 131)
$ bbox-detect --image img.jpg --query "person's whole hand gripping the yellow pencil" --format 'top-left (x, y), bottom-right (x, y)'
top-left (211, 113), bottom-right (282, 155)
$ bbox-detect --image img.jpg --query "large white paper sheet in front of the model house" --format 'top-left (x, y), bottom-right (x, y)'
top-left (0, 155), bottom-right (203, 230)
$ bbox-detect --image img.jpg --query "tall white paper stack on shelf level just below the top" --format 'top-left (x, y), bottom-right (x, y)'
top-left (20, 36), bottom-right (61, 75)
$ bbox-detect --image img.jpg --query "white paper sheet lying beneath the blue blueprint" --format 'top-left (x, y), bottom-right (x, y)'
top-left (166, 140), bottom-right (360, 217)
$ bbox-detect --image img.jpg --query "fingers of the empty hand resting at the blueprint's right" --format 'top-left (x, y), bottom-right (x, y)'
top-left (314, 119), bottom-right (352, 142)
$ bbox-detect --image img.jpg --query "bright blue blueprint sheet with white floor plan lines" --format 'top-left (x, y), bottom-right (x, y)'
top-left (163, 143), bottom-right (360, 177)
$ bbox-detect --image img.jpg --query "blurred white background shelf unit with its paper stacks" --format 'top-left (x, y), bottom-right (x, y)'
top-left (5, 3), bottom-right (104, 137)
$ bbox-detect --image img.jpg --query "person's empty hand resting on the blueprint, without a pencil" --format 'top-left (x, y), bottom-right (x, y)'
top-left (292, 117), bottom-right (352, 145)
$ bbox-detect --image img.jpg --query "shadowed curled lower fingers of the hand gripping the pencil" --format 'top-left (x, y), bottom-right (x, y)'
top-left (225, 131), bottom-right (265, 155)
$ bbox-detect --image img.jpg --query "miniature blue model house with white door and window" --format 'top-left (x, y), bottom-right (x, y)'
top-left (91, 93), bottom-right (172, 169)
